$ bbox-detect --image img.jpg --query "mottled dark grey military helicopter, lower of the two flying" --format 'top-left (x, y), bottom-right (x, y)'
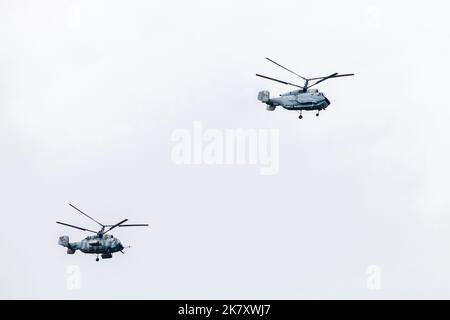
top-left (56, 203), bottom-right (148, 261)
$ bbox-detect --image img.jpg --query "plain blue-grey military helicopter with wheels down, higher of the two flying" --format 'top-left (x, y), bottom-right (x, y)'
top-left (256, 58), bottom-right (354, 119)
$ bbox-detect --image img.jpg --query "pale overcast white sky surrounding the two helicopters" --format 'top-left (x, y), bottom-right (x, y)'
top-left (0, 0), bottom-right (450, 299)
